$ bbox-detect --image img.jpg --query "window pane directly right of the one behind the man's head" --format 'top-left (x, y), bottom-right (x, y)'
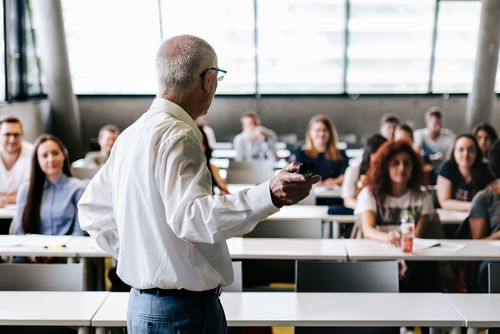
top-left (257, 0), bottom-right (345, 94)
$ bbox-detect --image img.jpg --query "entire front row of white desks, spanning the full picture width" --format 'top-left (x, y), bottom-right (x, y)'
top-left (0, 291), bottom-right (500, 332)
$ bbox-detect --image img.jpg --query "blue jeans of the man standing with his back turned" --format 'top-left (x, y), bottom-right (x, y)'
top-left (127, 288), bottom-right (227, 334)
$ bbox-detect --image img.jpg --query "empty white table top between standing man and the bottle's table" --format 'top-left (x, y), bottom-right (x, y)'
top-left (227, 238), bottom-right (347, 261)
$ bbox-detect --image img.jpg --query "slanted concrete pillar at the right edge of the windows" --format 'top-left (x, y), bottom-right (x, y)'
top-left (465, 0), bottom-right (500, 130)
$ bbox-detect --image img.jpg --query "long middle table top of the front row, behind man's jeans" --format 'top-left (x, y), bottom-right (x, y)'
top-left (92, 292), bottom-right (465, 327)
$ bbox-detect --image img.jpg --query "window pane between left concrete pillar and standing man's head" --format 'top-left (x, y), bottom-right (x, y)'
top-left (62, 0), bottom-right (161, 94)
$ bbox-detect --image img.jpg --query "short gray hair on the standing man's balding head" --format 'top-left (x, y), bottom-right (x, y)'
top-left (156, 35), bottom-right (217, 96)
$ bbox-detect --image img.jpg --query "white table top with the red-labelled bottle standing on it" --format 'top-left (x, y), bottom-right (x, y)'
top-left (344, 239), bottom-right (500, 261)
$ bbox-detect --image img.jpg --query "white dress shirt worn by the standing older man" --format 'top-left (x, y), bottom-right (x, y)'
top-left (78, 98), bottom-right (278, 291)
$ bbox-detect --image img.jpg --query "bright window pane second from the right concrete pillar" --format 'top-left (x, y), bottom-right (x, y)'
top-left (346, 0), bottom-right (435, 93)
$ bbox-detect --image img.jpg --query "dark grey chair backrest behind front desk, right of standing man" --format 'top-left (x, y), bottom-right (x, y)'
top-left (295, 261), bottom-right (399, 292)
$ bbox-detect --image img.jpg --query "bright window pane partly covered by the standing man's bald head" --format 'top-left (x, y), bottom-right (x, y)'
top-left (161, 0), bottom-right (255, 94)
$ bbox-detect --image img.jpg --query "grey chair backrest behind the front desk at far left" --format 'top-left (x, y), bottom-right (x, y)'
top-left (0, 263), bottom-right (83, 291)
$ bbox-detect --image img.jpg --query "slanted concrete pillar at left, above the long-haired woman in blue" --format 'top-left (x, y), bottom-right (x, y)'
top-left (31, 0), bottom-right (83, 160)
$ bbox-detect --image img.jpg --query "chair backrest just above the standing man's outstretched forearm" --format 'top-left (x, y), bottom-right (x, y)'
top-left (226, 160), bottom-right (275, 184)
